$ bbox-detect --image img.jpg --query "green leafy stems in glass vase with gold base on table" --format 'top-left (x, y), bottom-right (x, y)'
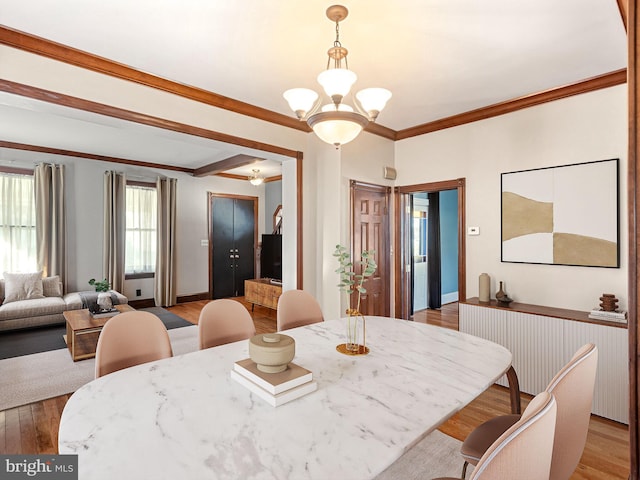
top-left (333, 245), bottom-right (378, 355)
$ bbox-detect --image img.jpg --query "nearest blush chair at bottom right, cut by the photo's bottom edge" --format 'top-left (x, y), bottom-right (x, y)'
top-left (435, 391), bottom-right (557, 480)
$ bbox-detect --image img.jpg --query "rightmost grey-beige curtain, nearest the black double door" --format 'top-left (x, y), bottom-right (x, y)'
top-left (154, 177), bottom-right (177, 306)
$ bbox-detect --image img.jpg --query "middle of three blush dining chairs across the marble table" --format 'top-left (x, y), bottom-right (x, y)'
top-left (198, 298), bottom-right (256, 350)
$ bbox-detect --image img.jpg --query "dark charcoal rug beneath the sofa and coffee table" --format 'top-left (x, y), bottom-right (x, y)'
top-left (0, 307), bottom-right (193, 360)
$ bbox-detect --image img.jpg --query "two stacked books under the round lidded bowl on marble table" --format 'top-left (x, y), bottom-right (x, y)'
top-left (231, 358), bottom-right (318, 407)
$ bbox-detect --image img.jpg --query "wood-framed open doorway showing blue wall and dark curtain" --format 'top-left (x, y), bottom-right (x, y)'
top-left (395, 178), bottom-right (466, 319)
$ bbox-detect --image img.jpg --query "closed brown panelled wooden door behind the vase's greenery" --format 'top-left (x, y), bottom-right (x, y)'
top-left (351, 181), bottom-right (391, 316)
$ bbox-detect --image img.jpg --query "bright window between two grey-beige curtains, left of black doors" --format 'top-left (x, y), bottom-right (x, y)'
top-left (125, 185), bottom-right (158, 275)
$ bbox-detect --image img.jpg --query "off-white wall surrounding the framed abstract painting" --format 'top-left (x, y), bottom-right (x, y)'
top-left (395, 85), bottom-right (628, 310)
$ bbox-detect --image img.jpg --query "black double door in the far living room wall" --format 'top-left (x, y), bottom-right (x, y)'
top-left (210, 195), bottom-right (256, 298)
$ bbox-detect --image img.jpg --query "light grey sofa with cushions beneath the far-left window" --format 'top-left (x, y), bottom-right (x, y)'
top-left (0, 272), bottom-right (128, 332)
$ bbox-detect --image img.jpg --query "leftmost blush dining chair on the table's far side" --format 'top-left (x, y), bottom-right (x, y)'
top-left (95, 310), bottom-right (173, 378)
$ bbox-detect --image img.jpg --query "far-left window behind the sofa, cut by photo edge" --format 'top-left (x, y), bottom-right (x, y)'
top-left (0, 172), bottom-right (38, 274)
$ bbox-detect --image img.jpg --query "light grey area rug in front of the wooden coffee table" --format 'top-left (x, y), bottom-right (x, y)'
top-left (0, 325), bottom-right (198, 411)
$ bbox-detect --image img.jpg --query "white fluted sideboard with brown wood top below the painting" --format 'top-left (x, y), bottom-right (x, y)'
top-left (459, 297), bottom-right (629, 424)
